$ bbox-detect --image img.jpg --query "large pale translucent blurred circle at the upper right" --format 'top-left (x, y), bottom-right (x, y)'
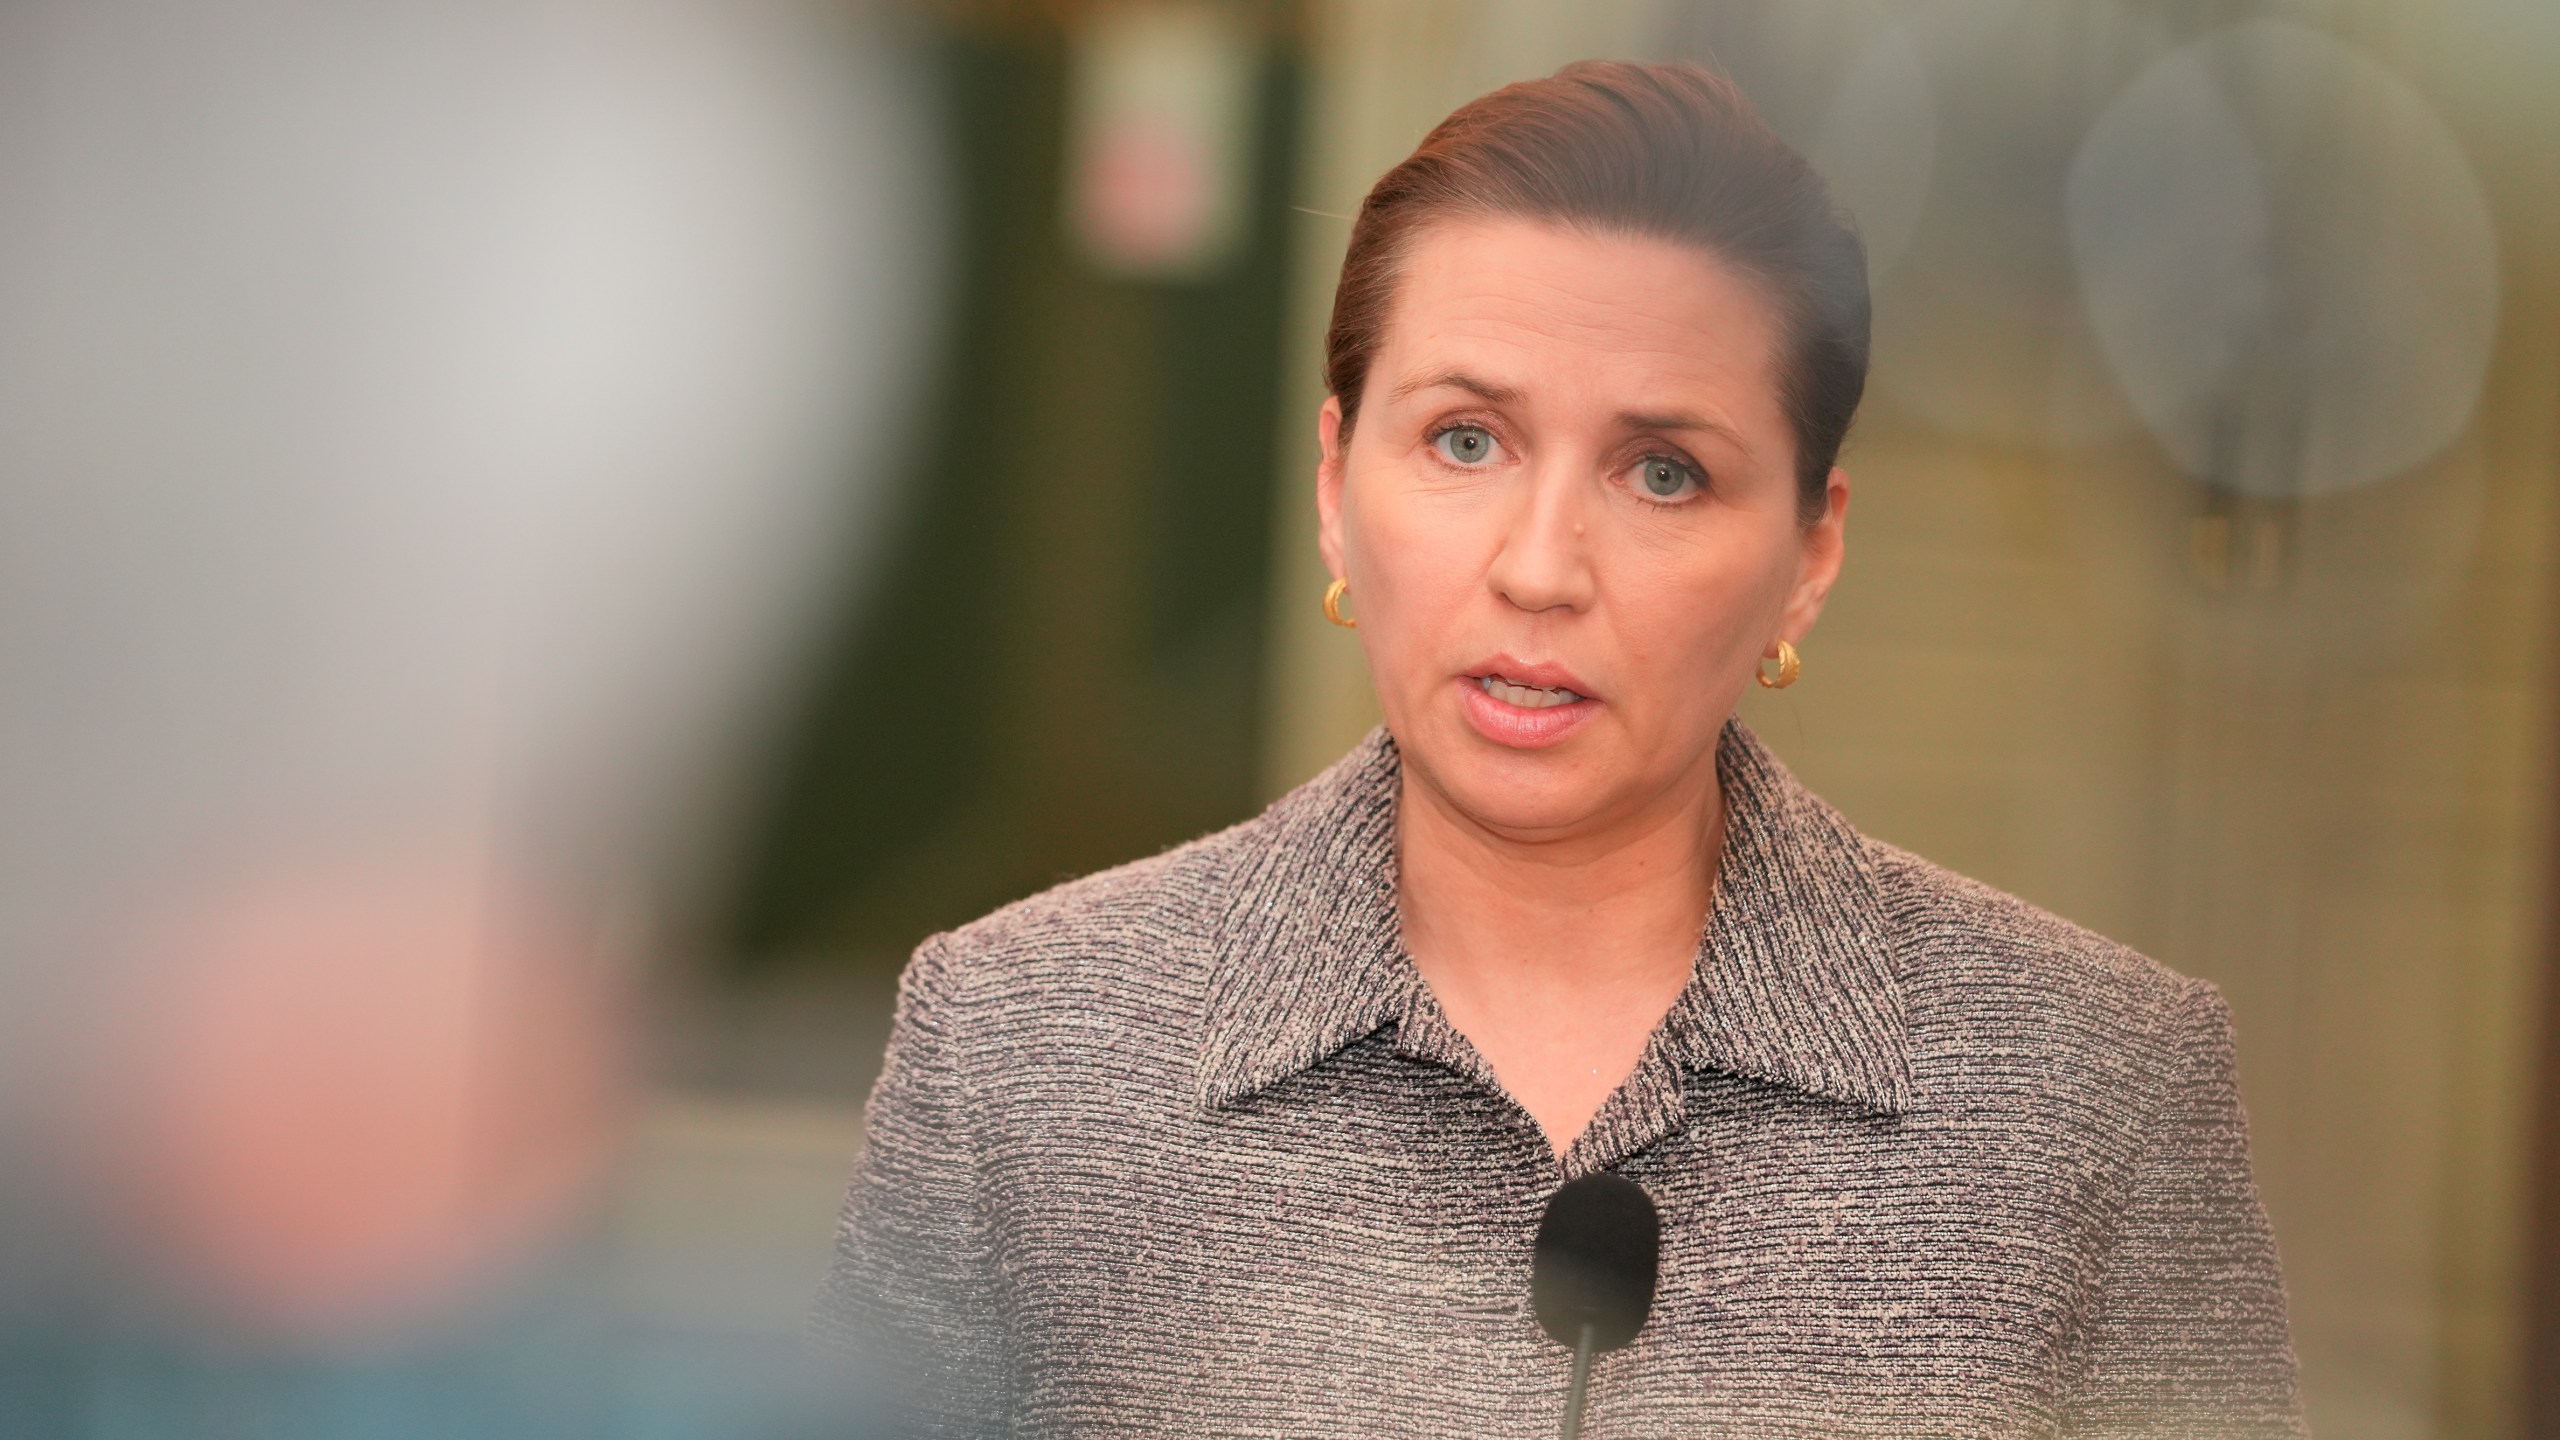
top-left (2063, 20), bottom-right (2499, 497)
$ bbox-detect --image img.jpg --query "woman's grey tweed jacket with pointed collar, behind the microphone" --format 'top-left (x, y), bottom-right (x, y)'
top-left (819, 723), bottom-right (2301, 1440)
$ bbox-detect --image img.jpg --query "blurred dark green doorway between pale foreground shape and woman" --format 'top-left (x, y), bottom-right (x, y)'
top-left (724, 5), bottom-right (1303, 969)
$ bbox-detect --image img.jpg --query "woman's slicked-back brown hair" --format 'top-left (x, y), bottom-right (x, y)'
top-left (1324, 61), bottom-right (1869, 523)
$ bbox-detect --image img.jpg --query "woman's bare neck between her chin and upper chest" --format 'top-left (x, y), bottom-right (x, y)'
top-left (1398, 732), bottom-right (1723, 1010)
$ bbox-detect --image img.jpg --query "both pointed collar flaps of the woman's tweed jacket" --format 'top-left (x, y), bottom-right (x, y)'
top-left (1198, 720), bottom-right (1912, 1112)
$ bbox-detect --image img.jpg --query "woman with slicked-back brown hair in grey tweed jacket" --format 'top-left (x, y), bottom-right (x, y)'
top-left (822, 64), bottom-right (2299, 1437)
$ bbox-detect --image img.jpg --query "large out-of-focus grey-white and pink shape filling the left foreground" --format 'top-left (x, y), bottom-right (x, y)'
top-left (0, 0), bottom-right (937, 1435)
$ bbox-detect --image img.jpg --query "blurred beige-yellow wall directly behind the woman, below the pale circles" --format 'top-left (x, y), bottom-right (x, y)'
top-left (1267, 0), bottom-right (2560, 1437)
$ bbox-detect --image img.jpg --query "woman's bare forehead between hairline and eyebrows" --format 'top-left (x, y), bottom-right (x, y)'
top-left (1370, 218), bottom-right (1779, 423)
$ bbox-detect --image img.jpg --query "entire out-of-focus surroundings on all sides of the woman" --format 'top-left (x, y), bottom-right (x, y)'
top-left (0, 0), bottom-right (2560, 1440)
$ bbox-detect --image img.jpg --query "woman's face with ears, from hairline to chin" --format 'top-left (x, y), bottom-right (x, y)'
top-left (1316, 218), bottom-right (1848, 838)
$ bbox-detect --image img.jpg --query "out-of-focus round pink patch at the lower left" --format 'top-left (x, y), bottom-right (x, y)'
top-left (77, 858), bottom-right (625, 1343)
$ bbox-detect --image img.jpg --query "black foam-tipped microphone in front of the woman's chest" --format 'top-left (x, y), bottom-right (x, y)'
top-left (1528, 1171), bottom-right (1661, 1440)
